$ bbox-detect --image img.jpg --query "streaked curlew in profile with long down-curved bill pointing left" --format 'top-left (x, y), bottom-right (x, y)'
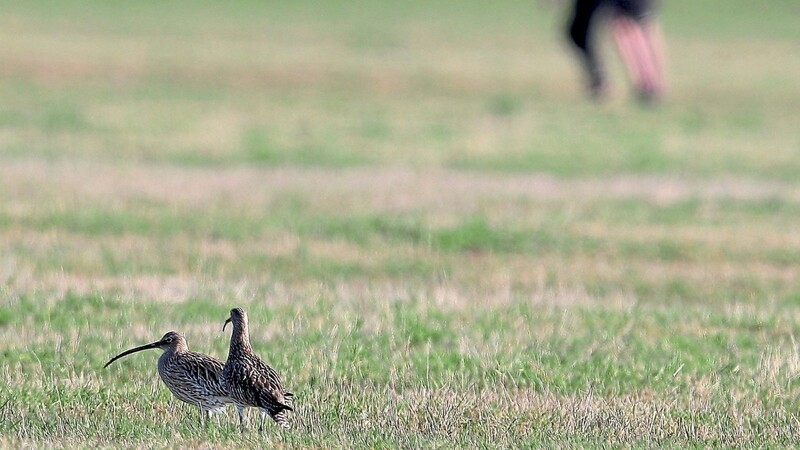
top-left (103, 331), bottom-right (231, 422)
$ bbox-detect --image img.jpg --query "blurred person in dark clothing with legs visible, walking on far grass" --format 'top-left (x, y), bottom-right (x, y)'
top-left (568, 0), bottom-right (664, 102)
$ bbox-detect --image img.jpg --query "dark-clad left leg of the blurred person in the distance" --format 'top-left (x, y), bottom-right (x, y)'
top-left (567, 0), bottom-right (605, 96)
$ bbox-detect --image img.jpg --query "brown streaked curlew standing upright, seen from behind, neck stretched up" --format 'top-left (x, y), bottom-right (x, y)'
top-left (222, 308), bottom-right (294, 430)
